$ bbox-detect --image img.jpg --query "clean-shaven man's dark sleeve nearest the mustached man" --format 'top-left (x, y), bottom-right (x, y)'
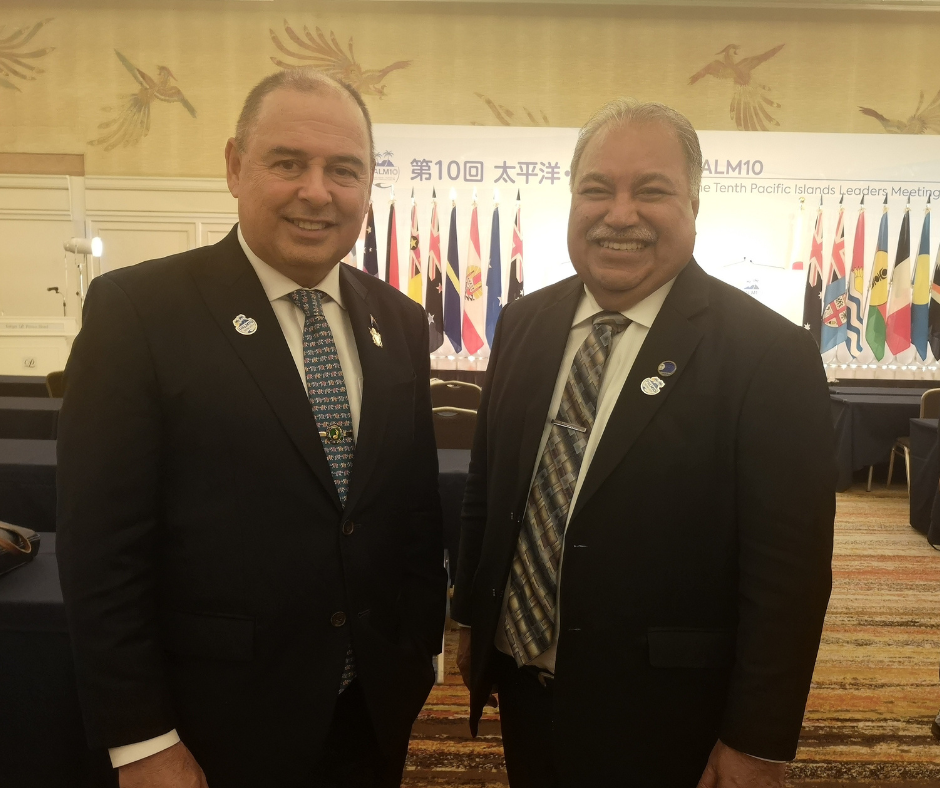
top-left (404, 308), bottom-right (447, 654)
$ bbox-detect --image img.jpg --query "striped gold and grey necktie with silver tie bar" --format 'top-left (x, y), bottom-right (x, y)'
top-left (504, 312), bottom-right (630, 666)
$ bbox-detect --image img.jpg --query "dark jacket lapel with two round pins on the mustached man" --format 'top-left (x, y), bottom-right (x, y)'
top-left (572, 260), bottom-right (708, 519)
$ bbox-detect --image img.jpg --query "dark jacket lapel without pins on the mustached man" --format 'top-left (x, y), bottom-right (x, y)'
top-left (515, 277), bottom-right (584, 511)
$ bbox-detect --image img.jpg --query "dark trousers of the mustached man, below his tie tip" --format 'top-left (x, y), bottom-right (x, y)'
top-left (493, 652), bottom-right (560, 788)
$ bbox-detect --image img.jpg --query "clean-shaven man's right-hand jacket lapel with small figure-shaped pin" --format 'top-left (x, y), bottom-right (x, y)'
top-left (339, 265), bottom-right (414, 511)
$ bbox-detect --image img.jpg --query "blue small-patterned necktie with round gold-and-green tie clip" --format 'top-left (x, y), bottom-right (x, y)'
top-left (290, 290), bottom-right (356, 692)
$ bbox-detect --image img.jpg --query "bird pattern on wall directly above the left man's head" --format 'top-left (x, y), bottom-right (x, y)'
top-left (268, 19), bottom-right (411, 99)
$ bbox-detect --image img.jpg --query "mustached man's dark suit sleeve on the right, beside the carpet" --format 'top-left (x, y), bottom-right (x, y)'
top-left (720, 332), bottom-right (836, 760)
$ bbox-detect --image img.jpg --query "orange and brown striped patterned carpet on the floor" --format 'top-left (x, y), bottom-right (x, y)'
top-left (403, 486), bottom-right (940, 788)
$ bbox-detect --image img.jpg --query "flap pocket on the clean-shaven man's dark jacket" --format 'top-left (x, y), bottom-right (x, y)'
top-left (162, 610), bottom-right (255, 662)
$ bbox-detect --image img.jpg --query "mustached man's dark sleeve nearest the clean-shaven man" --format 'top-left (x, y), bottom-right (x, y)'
top-left (450, 307), bottom-right (508, 626)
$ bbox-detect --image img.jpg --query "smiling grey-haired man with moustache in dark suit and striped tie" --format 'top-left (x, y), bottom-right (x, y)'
top-left (452, 100), bottom-right (835, 788)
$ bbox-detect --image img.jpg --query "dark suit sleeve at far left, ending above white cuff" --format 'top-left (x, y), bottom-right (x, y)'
top-left (57, 276), bottom-right (176, 747)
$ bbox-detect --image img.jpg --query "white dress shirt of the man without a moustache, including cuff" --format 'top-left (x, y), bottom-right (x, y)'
top-left (108, 227), bottom-right (362, 768)
